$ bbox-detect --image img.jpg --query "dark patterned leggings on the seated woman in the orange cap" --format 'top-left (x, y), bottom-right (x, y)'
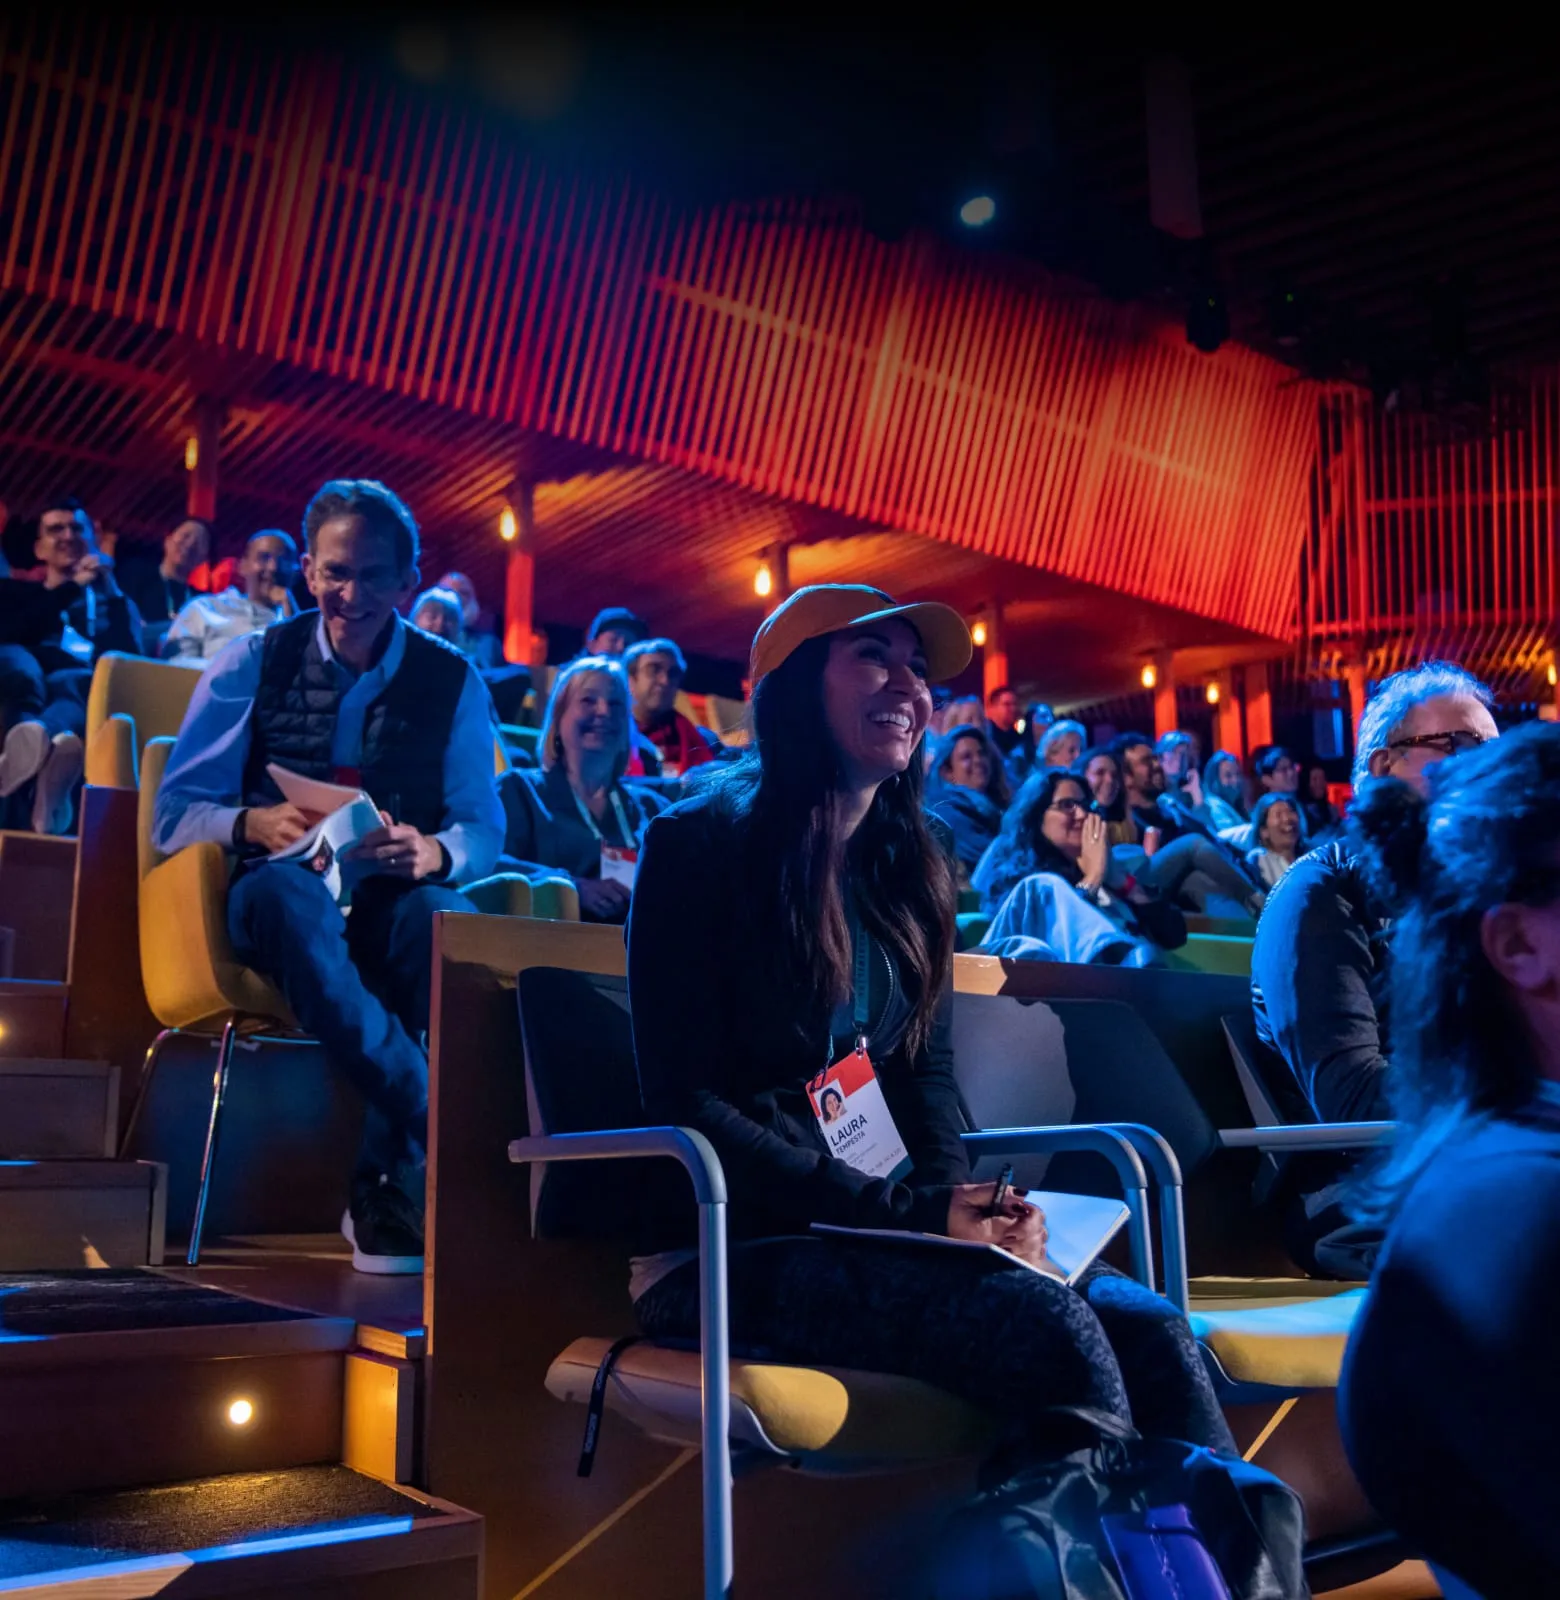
top-left (635, 1237), bottom-right (1235, 1454)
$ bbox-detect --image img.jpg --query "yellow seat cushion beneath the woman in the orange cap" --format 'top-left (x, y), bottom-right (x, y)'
top-left (547, 1339), bottom-right (998, 1472)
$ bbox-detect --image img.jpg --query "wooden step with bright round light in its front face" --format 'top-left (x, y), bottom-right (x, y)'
top-left (0, 1270), bottom-right (356, 1501)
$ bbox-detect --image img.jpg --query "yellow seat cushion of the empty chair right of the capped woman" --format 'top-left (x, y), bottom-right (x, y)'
top-left (1189, 1280), bottom-right (1365, 1389)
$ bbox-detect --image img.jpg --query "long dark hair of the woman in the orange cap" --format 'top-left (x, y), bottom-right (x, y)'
top-left (699, 635), bottom-right (955, 1056)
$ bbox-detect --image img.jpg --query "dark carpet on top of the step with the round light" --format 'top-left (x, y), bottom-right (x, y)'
top-left (0, 1267), bottom-right (309, 1341)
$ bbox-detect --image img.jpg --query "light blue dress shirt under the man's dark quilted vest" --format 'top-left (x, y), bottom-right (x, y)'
top-left (152, 618), bottom-right (504, 883)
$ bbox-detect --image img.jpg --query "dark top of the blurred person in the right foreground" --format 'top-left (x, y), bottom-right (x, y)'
top-left (1338, 1099), bottom-right (1560, 1600)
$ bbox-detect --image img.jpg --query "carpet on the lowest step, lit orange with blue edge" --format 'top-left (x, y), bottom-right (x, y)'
top-left (0, 1467), bottom-right (438, 1579)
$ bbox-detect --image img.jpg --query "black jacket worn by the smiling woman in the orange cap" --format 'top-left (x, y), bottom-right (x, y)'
top-left (629, 795), bottom-right (970, 1248)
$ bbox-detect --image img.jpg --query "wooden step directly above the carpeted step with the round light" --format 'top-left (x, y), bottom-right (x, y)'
top-left (0, 1160), bottom-right (168, 1272)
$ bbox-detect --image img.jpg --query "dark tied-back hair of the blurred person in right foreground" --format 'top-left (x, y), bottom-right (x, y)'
top-left (1349, 722), bottom-right (1560, 1222)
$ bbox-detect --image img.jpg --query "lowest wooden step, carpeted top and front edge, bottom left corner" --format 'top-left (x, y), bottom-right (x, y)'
top-left (0, 1466), bottom-right (482, 1600)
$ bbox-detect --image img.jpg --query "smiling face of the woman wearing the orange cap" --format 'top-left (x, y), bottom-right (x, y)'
top-left (824, 618), bottom-right (931, 789)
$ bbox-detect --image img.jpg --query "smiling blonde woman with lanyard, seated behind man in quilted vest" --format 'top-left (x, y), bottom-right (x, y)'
top-left (499, 656), bottom-right (664, 922)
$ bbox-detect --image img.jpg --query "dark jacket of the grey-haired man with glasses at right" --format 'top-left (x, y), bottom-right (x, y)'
top-left (1251, 842), bottom-right (1392, 1122)
